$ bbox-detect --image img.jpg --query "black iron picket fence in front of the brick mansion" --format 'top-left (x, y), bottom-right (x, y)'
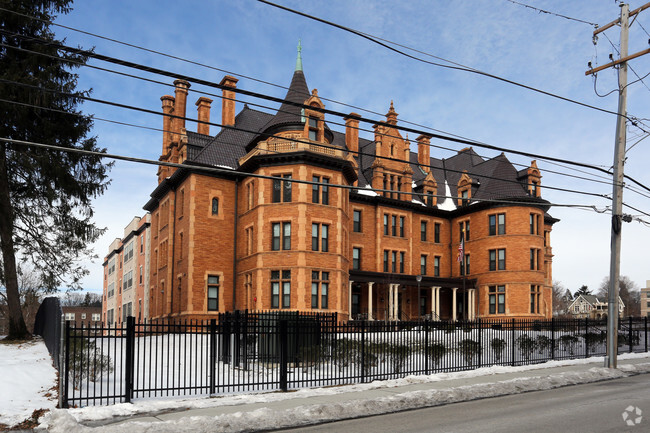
top-left (63, 312), bottom-right (648, 407)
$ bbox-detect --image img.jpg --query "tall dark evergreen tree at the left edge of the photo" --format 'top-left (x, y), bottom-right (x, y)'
top-left (0, 0), bottom-right (109, 339)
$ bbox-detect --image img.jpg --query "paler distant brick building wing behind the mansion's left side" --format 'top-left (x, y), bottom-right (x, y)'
top-left (102, 214), bottom-right (151, 325)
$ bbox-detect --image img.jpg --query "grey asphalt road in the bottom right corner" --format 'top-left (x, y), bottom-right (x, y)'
top-left (286, 374), bottom-right (650, 433)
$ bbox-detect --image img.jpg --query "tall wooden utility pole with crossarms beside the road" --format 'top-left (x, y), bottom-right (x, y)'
top-left (585, 3), bottom-right (650, 368)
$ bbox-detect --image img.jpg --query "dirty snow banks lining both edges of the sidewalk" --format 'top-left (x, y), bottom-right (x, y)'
top-left (36, 353), bottom-right (650, 433)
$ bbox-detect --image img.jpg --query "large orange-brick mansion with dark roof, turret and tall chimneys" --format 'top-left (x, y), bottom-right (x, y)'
top-left (105, 51), bottom-right (557, 320)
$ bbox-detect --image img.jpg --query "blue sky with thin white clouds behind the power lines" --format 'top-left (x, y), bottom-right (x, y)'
top-left (50, 0), bottom-right (650, 291)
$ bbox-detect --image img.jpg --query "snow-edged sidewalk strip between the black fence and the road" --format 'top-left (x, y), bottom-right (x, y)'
top-left (36, 354), bottom-right (650, 433)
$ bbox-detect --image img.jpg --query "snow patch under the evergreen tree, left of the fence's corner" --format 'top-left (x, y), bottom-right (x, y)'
top-left (0, 337), bottom-right (58, 426)
